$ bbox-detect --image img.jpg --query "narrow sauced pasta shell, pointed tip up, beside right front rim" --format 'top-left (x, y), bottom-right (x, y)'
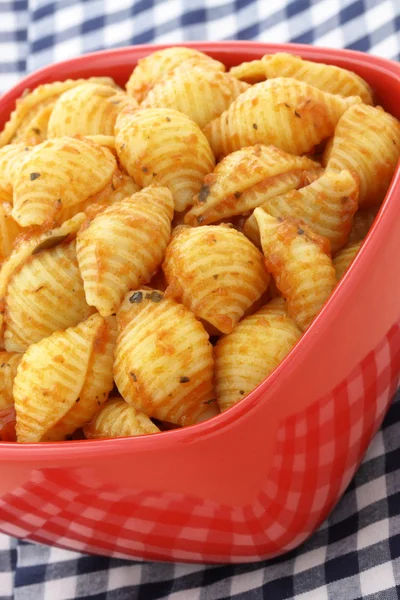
top-left (254, 208), bottom-right (336, 331)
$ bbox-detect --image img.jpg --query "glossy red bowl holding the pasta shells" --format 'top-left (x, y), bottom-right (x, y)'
top-left (0, 42), bottom-right (400, 563)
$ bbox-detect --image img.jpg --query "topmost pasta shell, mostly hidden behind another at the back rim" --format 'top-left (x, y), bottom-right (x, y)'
top-left (126, 46), bottom-right (225, 103)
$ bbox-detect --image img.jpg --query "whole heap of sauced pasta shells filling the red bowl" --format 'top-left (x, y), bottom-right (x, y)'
top-left (0, 47), bottom-right (400, 443)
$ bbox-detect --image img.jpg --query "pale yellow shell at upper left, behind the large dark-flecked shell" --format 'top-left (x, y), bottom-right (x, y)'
top-left (48, 82), bottom-right (139, 138)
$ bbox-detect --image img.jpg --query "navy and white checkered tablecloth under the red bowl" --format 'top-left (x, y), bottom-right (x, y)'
top-left (0, 0), bottom-right (400, 600)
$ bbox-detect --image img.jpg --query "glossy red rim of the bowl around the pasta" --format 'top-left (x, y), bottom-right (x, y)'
top-left (0, 40), bottom-right (400, 464)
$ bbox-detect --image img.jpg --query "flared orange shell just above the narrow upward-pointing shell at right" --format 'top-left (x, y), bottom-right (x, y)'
top-left (245, 171), bottom-right (358, 252)
